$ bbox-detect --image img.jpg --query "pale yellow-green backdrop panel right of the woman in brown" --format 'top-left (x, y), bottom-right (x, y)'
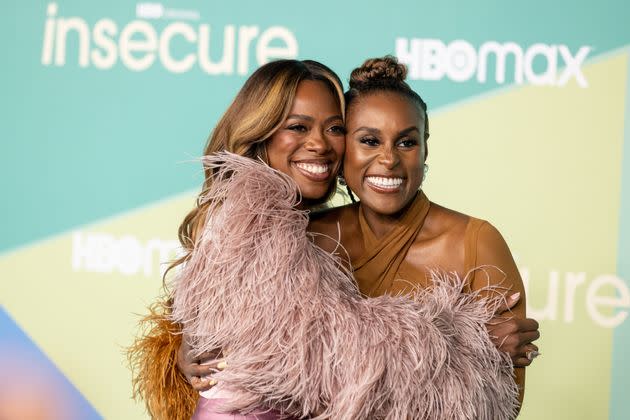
top-left (427, 52), bottom-right (628, 419)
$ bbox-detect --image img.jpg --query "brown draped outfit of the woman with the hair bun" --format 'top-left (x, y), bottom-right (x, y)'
top-left (356, 191), bottom-right (522, 298)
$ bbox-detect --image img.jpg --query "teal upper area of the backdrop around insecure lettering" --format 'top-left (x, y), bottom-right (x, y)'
top-left (0, 0), bottom-right (630, 252)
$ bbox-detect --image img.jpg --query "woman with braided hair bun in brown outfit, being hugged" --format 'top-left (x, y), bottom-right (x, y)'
top-left (310, 56), bottom-right (540, 401)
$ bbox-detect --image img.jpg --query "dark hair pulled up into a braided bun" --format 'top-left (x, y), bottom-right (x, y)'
top-left (345, 55), bottom-right (429, 141)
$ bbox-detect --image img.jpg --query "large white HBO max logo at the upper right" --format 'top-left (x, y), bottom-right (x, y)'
top-left (396, 38), bottom-right (591, 88)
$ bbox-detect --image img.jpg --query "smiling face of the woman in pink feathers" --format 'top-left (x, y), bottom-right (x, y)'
top-left (267, 80), bottom-right (345, 203)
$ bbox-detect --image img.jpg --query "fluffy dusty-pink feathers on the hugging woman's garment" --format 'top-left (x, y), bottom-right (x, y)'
top-left (172, 153), bottom-right (518, 420)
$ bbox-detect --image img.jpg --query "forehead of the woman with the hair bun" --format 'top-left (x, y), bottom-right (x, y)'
top-left (346, 92), bottom-right (424, 129)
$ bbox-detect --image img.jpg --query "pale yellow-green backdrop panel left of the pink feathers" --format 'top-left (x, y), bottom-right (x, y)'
top-left (0, 194), bottom-right (194, 419)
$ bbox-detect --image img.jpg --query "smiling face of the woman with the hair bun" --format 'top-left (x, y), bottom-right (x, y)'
top-left (344, 92), bottom-right (426, 216)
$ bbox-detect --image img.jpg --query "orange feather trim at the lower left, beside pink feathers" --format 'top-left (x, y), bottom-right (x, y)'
top-left (127, 302), bottom-right (199, 420)
